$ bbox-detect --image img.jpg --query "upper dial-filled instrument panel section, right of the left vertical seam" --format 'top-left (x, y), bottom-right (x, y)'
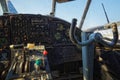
top-left (10, 14), bottom-right (70, 45)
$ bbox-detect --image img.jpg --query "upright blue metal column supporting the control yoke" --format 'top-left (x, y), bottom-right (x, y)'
top-left (81, 32), bottom-right (94, 80)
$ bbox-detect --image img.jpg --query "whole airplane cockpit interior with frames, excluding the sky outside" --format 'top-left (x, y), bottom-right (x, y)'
top-left (0, 0), bottom-right (120, 80)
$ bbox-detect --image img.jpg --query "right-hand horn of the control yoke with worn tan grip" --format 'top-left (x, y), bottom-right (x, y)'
top-left (95, 23), bottom-right (118, 47)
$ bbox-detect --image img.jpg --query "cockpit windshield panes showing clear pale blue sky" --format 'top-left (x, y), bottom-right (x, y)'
top-left (0, 0), bottom-right (120, 29)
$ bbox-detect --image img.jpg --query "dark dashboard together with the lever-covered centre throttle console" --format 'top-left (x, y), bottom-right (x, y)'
top-left (0, 0), bottom-right (82, 80)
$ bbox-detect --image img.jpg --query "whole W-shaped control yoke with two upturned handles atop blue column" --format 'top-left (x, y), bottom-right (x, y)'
top-left (69, 19), bottom-right (118, 47)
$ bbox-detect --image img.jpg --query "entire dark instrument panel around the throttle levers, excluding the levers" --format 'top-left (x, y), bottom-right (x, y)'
top-left (0, 14), bottom-right (81, 77)
